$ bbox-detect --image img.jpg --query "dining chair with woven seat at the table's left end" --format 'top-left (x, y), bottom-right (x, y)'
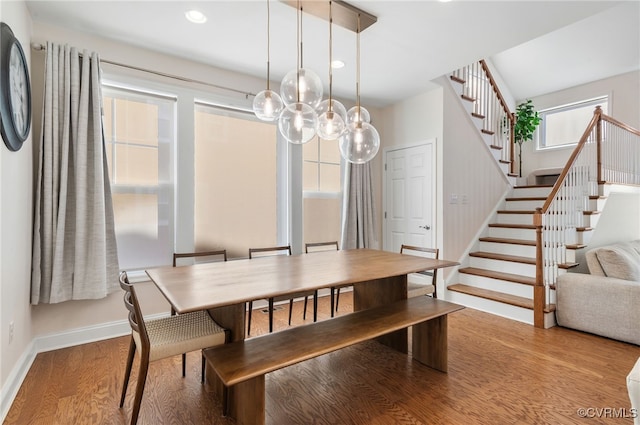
top-left (120, 272), bottom-right (229, 425)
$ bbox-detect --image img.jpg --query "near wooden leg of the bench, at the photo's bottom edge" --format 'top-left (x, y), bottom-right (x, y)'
top-left (228, 375), bottom-right (265, 425)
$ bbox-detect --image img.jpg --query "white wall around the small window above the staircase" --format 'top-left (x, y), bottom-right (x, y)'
top-left (518, 71), bottom-right (640, 177)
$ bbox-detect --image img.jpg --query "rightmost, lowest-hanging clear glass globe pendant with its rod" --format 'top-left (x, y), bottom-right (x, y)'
top-left (339, 14), bottom-right (380, 164)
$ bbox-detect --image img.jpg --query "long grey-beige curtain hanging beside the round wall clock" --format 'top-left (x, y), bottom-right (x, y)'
top-left (31, 43), bottom-right (118, 304)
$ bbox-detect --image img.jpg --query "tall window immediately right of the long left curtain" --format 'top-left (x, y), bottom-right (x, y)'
top-left (103, 86), bottom-right (176, 270)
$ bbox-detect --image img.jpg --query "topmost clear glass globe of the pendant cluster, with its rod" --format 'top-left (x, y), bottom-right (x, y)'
top-left (280, 0), bottom-right (322, 109)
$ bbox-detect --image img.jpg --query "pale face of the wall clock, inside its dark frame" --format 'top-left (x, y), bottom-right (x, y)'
top-left (9, 43), bottom-right (29, 138)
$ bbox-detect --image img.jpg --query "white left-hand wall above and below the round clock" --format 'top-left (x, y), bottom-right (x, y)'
top-left (0, 1), bottom-right (38, 413)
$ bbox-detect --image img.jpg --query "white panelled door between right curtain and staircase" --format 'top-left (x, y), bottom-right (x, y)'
top-left (384, 141), bottom-right (436, 252)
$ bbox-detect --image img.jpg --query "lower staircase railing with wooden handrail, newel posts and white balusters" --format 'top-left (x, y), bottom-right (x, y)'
top-left (533, 106), bottom-right (640, 327)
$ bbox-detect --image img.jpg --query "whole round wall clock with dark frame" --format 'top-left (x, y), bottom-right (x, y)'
top-left (0, 22), bottom-right (31, 151)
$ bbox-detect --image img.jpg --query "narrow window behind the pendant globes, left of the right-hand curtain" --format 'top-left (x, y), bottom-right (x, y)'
top-left (302, 137), bottom-right (342, 242)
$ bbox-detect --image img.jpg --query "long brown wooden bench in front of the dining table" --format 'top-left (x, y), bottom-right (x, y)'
top-left (204, 297), bottom-right (464, 425)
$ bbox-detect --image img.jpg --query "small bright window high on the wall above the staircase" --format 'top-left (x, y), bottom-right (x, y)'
top-left (537, 96), bottom-right (608, 150)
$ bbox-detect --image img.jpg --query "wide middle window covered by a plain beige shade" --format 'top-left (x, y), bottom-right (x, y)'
top-left (194, 104), bottom-right (278, 257)
